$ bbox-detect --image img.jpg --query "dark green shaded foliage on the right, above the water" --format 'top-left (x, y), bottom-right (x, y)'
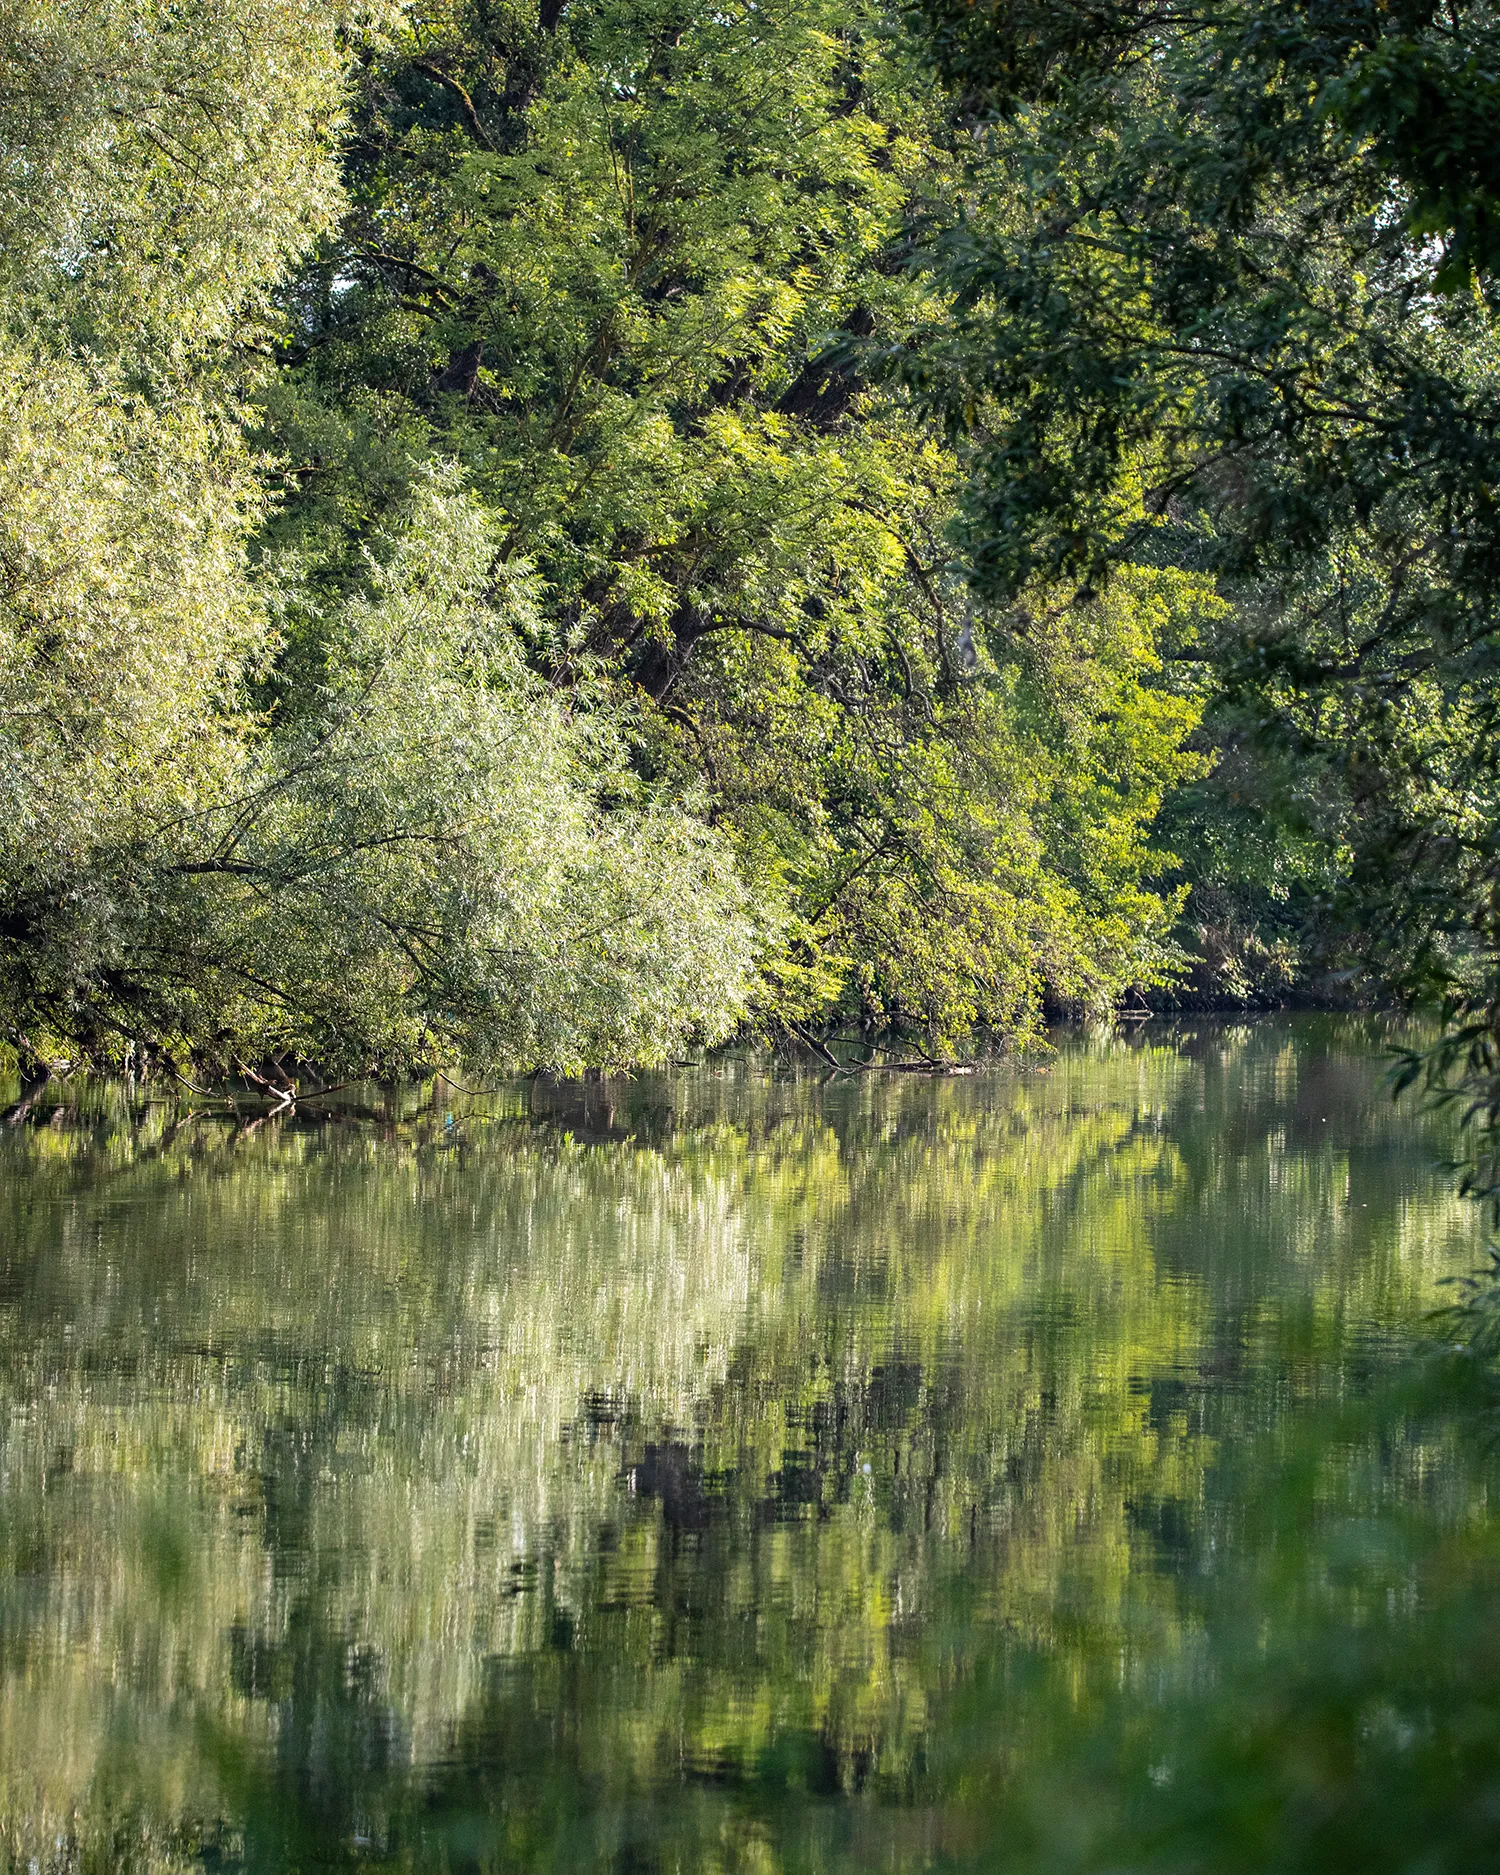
top-left (887, 0), bottom-right (1500, 1095)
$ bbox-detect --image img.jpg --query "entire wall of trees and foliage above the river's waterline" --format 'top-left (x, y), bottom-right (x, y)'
top-left (0, 0), bottom-right (1500, 1086)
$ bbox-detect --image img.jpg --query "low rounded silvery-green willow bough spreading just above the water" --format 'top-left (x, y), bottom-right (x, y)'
top-left (6, 486), bottom-right (756, 1088)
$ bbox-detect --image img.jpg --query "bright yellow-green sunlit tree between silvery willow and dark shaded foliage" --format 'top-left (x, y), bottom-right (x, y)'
top-left (263, 0), bottom-right (1213, 1046)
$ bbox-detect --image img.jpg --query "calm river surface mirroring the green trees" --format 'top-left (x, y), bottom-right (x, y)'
top-left (0, 1018), bottom-right (1500, 1871)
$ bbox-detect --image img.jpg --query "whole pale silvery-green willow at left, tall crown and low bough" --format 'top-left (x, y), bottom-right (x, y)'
top-left (0, 0), bottom-right (750, 1082)
